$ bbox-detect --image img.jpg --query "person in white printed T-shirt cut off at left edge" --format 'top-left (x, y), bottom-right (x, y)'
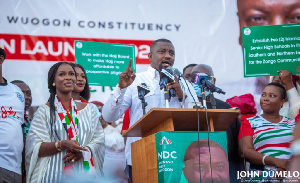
top-left (0, 48), bottom-right (25, 183)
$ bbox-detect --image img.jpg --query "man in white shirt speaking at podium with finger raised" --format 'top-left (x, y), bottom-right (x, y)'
top-left (102, 39), bottom-right (198, 178)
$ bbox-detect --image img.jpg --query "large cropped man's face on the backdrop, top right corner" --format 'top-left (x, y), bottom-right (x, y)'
top-left (237, 0), bottom-right (300, 45)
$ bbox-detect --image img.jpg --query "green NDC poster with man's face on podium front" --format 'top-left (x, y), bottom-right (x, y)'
top-left (155, 132), bottom-right (229, 183)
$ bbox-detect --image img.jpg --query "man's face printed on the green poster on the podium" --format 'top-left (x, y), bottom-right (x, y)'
top-left (183, 147), bottom-right (230, 183)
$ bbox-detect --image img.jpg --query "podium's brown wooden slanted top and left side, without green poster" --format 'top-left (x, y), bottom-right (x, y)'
top-left (123, 108), bottom-right (239, 183)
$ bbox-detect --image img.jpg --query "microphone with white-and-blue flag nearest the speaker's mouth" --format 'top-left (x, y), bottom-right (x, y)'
top-left (159, 66), bottom-right (176, 97)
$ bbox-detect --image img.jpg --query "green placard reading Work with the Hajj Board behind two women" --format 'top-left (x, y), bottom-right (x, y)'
top-left (75, 41), bottom-right (136, 86)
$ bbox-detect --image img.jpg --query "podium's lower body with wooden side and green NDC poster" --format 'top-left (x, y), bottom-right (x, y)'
top-left (132, 132), bottom-right (229, 183)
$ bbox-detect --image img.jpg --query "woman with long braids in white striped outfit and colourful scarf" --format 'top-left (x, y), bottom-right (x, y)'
top-left (26, 62), bottom-right (105, 182)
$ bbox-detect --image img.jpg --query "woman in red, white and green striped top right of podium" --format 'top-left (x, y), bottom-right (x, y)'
top-left (239, 83), bottom-right (295, 181)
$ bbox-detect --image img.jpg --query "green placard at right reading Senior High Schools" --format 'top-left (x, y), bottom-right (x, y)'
top-left (242, 24), bottom-right (300, 77)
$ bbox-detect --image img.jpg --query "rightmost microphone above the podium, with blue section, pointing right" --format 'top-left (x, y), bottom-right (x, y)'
top-left (191, 71), bottom-right (226, 94)
